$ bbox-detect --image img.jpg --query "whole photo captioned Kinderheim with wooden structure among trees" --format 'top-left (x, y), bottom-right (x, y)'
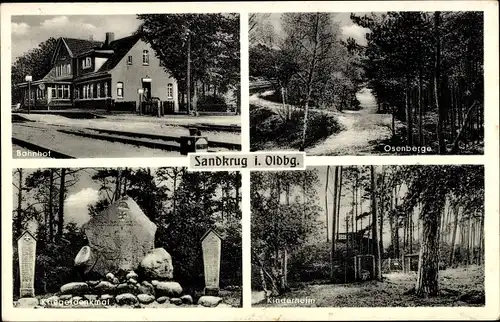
top-left (251, 165), bottom-right (485, 307)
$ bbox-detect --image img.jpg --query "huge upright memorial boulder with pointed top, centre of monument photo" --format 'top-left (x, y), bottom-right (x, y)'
top-left (75, 197), bottom-right (156, 276)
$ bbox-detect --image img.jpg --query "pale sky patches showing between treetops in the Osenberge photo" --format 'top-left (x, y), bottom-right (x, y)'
top-left (263, 12), bottom-right (369, 45)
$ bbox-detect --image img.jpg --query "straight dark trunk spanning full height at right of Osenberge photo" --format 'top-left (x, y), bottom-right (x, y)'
top-left (434, 11), bottom-right (446, 154)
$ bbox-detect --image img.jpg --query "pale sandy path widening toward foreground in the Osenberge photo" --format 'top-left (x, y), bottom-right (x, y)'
top-left (306, 88), bottom-right (398, 155)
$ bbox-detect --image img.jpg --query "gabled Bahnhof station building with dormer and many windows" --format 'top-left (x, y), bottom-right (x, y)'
top-left (18, 33), bottom-right (179, 112)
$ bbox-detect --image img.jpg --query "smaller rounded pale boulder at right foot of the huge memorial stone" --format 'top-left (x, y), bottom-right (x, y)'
top-left (139, 248), bottom-right (174, 280)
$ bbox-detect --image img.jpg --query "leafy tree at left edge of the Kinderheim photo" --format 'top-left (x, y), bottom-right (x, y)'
top-left (251, 170), bottom-right (319, 294)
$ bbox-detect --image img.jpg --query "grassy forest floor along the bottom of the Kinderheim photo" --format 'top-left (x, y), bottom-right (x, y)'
top-left (255, 266), bottom-right (484, 307)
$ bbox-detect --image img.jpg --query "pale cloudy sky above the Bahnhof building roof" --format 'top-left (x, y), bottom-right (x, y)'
top-left (11, 15), bottom-right (141, 61)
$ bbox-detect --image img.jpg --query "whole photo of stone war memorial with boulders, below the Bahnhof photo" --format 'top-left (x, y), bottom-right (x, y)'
top-left (12, 167), bottom-right (242, 307)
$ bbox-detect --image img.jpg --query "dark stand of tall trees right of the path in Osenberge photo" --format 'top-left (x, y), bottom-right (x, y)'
top-left (351, 12), bottom-right (484, 154)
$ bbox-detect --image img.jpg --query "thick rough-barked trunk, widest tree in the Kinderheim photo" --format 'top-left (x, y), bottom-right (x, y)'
top-left (415, 181), bottom-right (446, 297)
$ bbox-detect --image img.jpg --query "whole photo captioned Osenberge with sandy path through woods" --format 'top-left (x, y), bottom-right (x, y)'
top-left (249, 11), bottom-right (484, 155)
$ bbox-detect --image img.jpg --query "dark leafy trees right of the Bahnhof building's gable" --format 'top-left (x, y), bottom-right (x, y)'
top-left (138, 14), bottom-right (240, 110)
